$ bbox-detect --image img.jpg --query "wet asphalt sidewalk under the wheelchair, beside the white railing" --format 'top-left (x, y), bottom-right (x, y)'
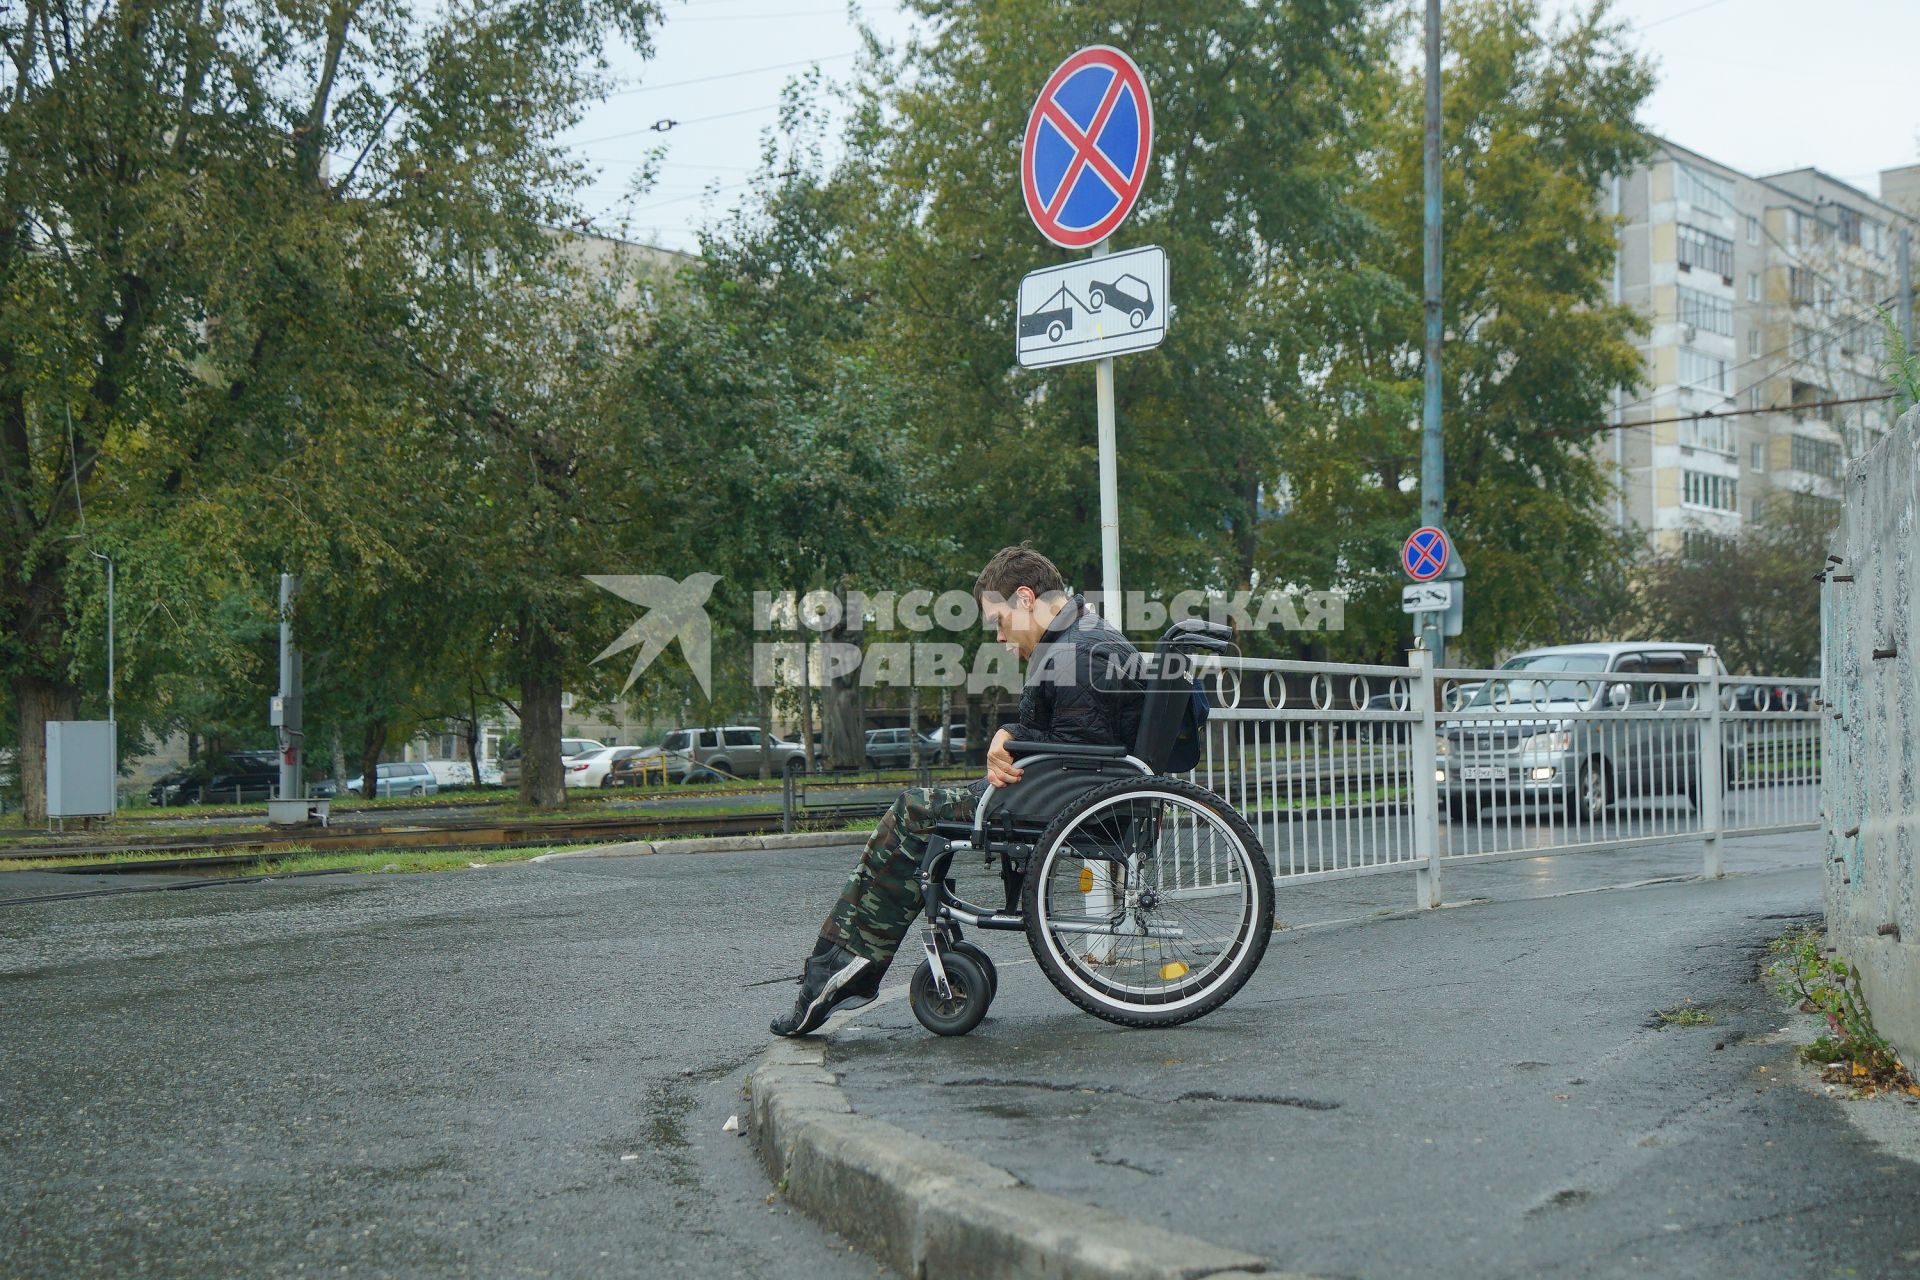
top-left (828, 835), bottom-right (1920, 1280)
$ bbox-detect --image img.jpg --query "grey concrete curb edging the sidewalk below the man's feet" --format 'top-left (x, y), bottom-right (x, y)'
top-left (747, 1040), bottom-right (1306, 1280)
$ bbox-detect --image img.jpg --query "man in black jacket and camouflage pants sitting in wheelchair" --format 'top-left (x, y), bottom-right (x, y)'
top-left (772, 543), bottom-right (1142, 1036)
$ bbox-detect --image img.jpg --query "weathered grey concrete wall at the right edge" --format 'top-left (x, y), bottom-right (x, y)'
top-left (1809, 409), bottom-right (1920, 1063)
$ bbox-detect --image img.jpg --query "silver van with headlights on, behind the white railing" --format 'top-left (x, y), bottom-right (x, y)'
top-left (1436, 643), bottom-right (1743, 821)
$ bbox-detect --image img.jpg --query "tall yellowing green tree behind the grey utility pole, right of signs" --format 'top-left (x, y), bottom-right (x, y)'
top-left (1263, 0), bottom-right (1651, 660)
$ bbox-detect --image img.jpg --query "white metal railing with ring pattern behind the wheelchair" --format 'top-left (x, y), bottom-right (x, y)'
top-left (1192, 647), bottom-right (1820, 906)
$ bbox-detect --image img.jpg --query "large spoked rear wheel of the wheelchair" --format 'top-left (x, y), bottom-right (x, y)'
top-left (1023, 777), bottom-right (1273, 1027)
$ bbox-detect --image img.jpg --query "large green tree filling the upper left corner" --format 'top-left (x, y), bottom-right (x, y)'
top-left (0, 0), bottom-right (657, 818)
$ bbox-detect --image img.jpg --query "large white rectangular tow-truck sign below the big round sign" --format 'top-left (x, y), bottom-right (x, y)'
top-left (1014, 246), bottom-right (1167, 368)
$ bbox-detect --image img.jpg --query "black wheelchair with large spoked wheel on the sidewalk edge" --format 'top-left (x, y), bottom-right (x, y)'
top-left (908, 620), bottom-right (1273, 1036)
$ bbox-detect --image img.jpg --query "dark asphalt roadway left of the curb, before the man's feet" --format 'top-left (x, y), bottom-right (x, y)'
top-left (0, 850), bottom-right (890, 1280)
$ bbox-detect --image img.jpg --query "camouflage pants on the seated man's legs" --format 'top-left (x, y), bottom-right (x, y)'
top-left (820, 783), bottom-right (983, 971)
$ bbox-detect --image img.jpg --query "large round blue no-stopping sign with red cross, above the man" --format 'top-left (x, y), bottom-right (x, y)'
top-left (1020, 44), bottom-right (1154, 249)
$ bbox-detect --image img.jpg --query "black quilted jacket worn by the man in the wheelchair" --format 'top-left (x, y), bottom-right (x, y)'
top-left (1008, 595), bottom-right (1144, 748)
